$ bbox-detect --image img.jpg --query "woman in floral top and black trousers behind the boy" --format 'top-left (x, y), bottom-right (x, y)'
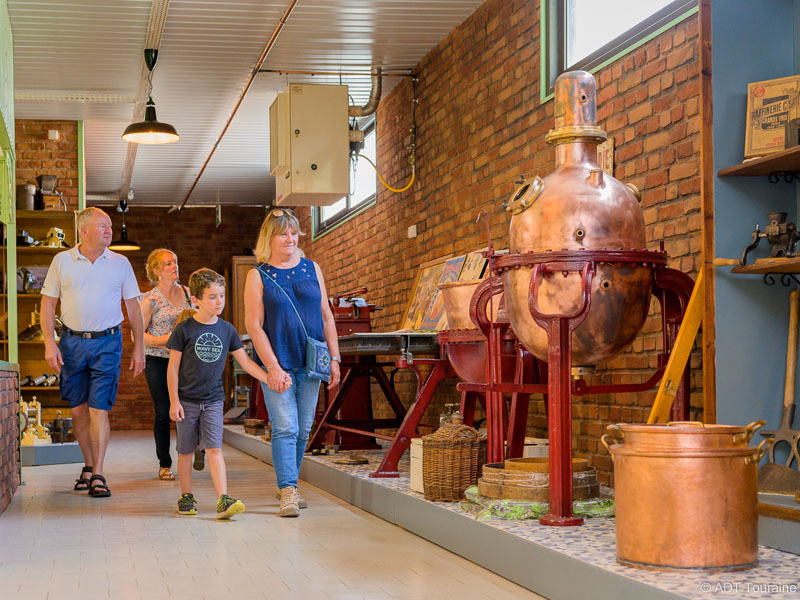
top-left (142, 248), bottom-right (191, 481)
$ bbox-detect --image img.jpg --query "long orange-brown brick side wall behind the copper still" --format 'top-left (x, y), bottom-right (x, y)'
top-left (303, 0), bottom-right (701, 481)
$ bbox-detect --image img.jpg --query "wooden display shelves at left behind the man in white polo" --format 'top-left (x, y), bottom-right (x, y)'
top-left (2, 210), bottom-right (77, 422)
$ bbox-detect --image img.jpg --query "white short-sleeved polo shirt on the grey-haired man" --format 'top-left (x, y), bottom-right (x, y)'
top-left (42, 246), bottom-right (140, 331)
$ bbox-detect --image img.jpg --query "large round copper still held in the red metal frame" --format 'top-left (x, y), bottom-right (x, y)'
top-left (503, 71), bottom-right (652, 366)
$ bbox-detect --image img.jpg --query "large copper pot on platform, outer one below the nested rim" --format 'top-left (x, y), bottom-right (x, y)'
top-left (603, 435), bottom-right (773, 571)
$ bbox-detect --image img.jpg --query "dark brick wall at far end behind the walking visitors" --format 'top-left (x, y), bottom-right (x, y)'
top-left (104, 206), bottom-right (264, 429)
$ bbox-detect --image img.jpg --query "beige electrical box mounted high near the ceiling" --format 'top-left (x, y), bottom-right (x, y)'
top-left (269, 83), bottom-right (350, 206)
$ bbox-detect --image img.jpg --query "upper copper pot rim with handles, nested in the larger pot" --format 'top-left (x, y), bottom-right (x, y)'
top-left (606, 421), bottom-right (766, 451)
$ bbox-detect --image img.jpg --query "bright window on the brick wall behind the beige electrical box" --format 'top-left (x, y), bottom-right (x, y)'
top-left (313, 120), bottom-right (377, 237)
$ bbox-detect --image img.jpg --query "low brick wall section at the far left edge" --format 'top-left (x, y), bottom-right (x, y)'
top-left (0, 371), bottom-right (19, 513)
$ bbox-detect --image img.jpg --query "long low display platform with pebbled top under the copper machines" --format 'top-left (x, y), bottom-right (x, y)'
top-left (223, 425), bottom-right (800, 600)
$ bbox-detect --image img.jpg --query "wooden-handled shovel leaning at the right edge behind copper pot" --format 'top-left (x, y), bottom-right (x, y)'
top-left (758, 290), bottom-right (800, 494)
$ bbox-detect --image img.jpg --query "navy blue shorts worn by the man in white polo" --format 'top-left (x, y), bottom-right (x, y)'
top-left (58, 328), bottom-right (122, 410)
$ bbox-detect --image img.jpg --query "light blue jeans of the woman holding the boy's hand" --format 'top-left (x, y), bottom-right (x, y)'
top-left (261, 369), bottom-right (320, 488)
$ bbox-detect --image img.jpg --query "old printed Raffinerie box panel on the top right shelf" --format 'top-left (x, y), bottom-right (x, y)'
top-left (744, 75), bottom-right (800, 158)
